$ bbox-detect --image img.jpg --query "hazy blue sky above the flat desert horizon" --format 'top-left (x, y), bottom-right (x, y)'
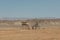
top-left (0, 0), bottom-right (60, 18)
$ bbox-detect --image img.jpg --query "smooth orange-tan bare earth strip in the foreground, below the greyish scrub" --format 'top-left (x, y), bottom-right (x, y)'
top-left (0, 27), bottom-right (60, 40)
